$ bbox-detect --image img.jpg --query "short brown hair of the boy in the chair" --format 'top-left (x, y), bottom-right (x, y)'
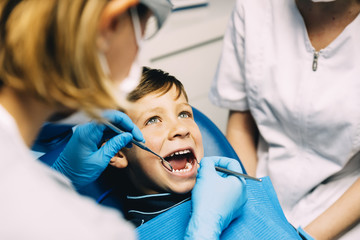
top-left (127, 67), bottom-right (188, 102)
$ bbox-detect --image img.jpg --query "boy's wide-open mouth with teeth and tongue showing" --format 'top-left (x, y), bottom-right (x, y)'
top-left (164, 149), bottom-right (196, 172)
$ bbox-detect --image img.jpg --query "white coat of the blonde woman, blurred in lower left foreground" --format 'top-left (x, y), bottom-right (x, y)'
top-left (0, 105), bottom-right (135, 240)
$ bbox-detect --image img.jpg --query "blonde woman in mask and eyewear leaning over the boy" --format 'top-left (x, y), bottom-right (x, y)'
top-left (0, 0), bottom-right (245, 239)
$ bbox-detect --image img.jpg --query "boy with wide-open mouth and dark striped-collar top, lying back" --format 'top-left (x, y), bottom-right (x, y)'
top-left (101, 68), bottom-right (208, 226)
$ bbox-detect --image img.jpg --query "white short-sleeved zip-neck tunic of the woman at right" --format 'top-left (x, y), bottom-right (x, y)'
top-left (210, 0), bottom-right (360, 239)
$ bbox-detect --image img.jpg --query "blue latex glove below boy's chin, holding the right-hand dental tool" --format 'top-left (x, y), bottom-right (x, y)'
top-left (185, 157), bottom-right (247, 240)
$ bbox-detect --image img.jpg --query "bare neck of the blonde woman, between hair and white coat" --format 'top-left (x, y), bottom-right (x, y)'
top-left (0, 87), bottom-right (54, 147)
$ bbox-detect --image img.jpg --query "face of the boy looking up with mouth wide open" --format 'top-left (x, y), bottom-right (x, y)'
top-left (123, 86), bottom-right (204, 194)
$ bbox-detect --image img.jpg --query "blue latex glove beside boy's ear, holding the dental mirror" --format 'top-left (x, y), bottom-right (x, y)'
top-left (52, 110), bottom-right (145, 189)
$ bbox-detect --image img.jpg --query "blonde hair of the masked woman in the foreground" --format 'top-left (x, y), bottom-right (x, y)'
top-left (0, 0), bottom-right (129, 114)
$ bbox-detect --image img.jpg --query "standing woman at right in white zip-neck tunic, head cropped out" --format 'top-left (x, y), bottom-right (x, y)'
top-left (210, 0), bottom-right (360, 239)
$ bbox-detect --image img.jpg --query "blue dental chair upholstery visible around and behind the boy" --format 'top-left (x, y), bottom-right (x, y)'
top-left (32, 108), bottom-right (245, 207)
